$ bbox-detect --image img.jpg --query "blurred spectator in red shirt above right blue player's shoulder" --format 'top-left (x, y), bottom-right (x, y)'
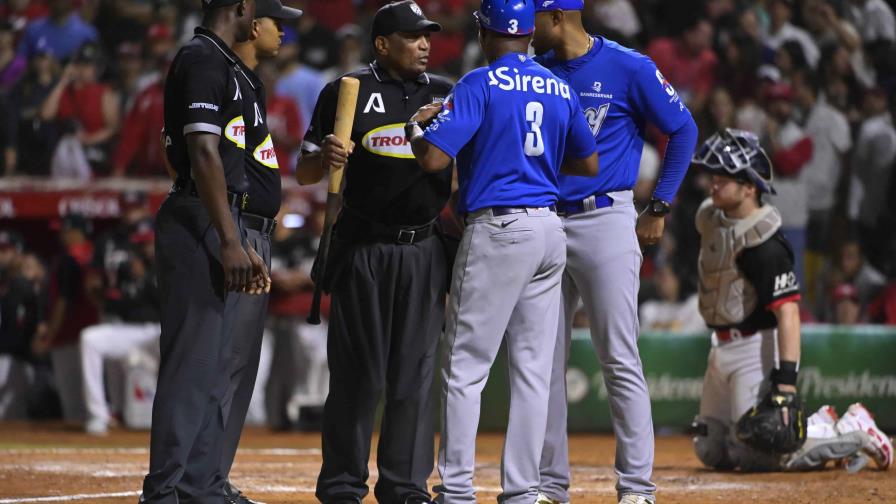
top-left (647, 17), bottom-right (718, 115)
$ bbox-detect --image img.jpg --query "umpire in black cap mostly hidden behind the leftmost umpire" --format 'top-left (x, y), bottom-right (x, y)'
top-left (221, 0), bottom-right (302, 504)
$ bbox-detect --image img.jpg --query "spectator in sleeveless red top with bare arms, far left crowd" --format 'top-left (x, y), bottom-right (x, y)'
top-left (40, 43), bottom-right (119, 173)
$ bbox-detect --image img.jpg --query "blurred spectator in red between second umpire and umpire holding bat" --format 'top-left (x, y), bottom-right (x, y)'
top-left (256, 63), bottom-right (307, 177)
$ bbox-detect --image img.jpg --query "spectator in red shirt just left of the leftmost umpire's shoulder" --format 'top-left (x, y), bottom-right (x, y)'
top-left (112, 57), bottom-right (166, 177)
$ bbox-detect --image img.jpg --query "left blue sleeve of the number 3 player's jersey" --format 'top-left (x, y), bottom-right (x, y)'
top-left (423, 79), bottom-right (487, 157)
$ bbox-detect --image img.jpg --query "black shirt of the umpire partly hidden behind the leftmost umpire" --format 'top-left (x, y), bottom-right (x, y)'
top-left (238, 60), bottom-right (281, 219)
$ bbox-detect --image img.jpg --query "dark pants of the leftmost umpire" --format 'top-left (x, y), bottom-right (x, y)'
top-left (141, 194), bottom-right (244, 504)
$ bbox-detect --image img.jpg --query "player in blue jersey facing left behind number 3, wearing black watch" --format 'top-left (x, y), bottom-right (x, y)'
top-left (533, 0), bottom-right (697, 504)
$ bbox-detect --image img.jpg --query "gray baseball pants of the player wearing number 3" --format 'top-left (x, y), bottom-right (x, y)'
top-left (435, 208), bottom-right (566, 504)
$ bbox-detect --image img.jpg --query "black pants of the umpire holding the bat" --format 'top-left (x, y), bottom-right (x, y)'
top-left (316, 236), bottom-right (447, 504)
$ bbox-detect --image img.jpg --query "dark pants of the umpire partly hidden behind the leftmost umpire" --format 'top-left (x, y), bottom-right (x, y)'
top-left (221, 226), bottom-right (271, 479)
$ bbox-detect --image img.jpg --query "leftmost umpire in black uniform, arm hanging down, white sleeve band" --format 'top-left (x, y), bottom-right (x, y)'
top-left (140, 0), bottom-right (267, 504)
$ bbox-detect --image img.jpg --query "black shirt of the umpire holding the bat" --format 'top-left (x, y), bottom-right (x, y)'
top-left (302, 62), bottom-right (452, 226)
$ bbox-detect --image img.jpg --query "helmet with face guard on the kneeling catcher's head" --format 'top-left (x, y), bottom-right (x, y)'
top-left (691, 128), bottom-right (776, 194)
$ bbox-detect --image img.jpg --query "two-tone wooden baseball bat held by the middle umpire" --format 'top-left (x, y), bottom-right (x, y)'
top-left (308, 77), bottom-right (361, 325)
